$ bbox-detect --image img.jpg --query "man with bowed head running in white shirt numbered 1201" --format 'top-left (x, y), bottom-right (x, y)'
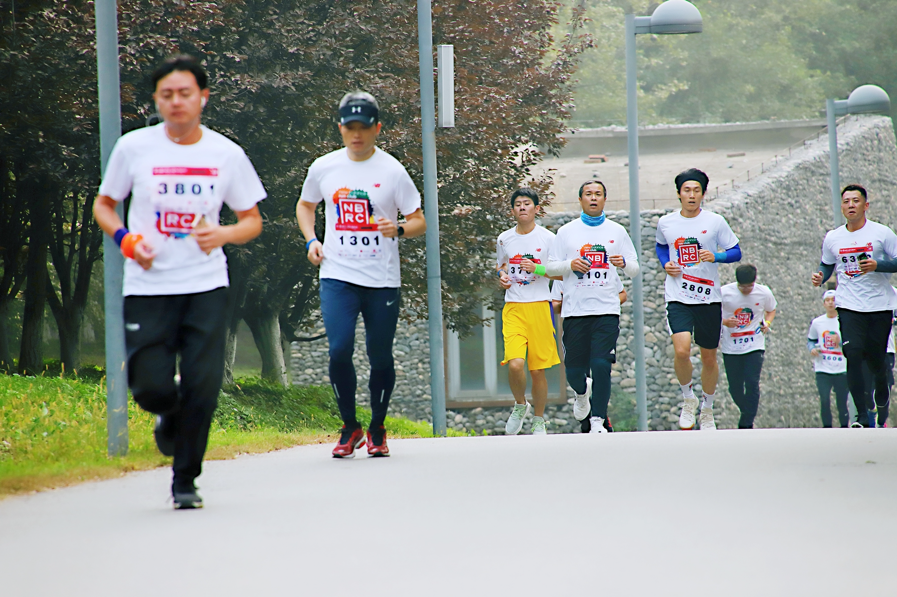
top-left (716, 264), bottom-right (776, 430)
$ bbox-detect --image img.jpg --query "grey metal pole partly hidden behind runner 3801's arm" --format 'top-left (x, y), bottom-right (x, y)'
top-left (94, 0), bottom-right (128, 456)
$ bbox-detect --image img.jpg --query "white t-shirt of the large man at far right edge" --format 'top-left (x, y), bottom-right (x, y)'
top-left (822, 220), bottom-right (897, 313)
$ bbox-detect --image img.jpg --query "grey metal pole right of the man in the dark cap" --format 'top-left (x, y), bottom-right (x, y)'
top-left (417, 0), bottom-right (445, 435)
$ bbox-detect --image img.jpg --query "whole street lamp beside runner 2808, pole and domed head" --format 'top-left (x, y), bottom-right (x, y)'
top-left (626, 0), bottom-right (706, 431)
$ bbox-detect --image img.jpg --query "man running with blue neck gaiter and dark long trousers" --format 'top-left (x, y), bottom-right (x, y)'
top-left (547, 180), bottom-right (639, 433)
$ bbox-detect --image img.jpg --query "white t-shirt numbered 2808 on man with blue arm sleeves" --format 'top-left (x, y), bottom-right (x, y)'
top-left (656, 209), bottom-right (738, 305)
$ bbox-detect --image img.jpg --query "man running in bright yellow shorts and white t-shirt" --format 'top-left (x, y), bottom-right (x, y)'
top-left (496, 188), bottom-right (561, 435)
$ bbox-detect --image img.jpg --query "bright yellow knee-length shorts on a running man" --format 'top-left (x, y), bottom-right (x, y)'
top-left (501, 301), bottom-right (561, 371)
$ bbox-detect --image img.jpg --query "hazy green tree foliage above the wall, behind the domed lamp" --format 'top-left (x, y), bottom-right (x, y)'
top-left (565, 0), bottom-right (897, 126)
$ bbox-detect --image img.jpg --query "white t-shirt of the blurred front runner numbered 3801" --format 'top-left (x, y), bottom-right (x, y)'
top-left (100, 123), bottom-right (266, 296)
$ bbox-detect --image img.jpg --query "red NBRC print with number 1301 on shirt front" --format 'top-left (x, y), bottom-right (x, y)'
top-left (333, 188), bottom-right (386, 259)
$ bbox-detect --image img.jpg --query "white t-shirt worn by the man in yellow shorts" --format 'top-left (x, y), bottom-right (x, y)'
top-left (495, 226), bottom-right (554, 303)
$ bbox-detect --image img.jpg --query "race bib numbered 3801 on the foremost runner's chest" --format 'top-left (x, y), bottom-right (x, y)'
top-left (152, 167), bottom-right (218, 238)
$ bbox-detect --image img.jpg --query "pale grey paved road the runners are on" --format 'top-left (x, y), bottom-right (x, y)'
top-left (0, 429), bottom-right (897, 597)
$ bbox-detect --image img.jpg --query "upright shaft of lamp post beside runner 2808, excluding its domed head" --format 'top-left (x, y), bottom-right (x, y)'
top-left (626, 14), bottom-right (648, 431)
